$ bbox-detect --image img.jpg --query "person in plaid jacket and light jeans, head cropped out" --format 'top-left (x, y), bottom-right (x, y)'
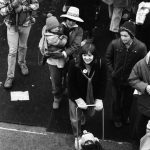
top-left (0, 0), bottom-right (39, 88)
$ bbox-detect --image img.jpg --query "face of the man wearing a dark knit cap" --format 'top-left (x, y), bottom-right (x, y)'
top-left (120, 31), bottom-right (132, 44)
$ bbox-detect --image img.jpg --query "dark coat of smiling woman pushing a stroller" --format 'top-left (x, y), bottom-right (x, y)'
top-left (68, 57), bottom-right (106, 101)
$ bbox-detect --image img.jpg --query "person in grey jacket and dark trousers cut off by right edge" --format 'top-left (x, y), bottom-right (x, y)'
top-left (129, 52), bottom-right (150, 140)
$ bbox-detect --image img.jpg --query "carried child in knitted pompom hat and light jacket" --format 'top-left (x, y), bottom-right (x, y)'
top-left (39, 13), bottom-right (67, 66)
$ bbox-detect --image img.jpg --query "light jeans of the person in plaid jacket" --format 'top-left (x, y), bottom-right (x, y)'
top-left (7, 26), bottom-right (31, 78)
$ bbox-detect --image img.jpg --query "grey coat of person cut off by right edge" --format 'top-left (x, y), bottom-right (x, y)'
top-left (129, 52), bottom-right (150, 117)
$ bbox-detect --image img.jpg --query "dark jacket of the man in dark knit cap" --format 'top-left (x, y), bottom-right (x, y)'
top-left (106, 38), bottom-right (147, 84)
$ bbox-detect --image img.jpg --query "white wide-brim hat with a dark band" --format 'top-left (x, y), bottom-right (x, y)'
top-left (60, 6), bottom-right (84, 22)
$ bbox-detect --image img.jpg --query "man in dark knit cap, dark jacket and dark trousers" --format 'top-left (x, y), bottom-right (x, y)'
top-left (106, 21), bottom-right (147, 127)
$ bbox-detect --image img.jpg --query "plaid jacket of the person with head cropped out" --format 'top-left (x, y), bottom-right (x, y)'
top-left (0, 0), bottom-right (39, 26)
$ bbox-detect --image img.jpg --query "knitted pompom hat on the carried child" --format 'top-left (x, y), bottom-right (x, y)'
top-left (46, 13), bottom-right (59, 30)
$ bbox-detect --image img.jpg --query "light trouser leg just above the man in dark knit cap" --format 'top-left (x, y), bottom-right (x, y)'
top-left (109, 7), bottom-right (123, 32)
